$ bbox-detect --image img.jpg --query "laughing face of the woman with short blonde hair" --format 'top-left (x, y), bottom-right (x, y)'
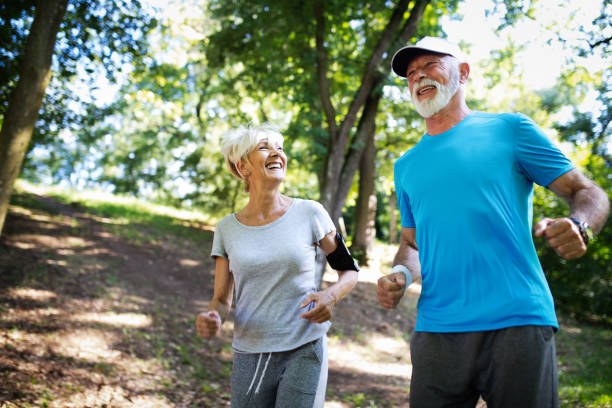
top-left (243, 139), bottom-right (287, 181)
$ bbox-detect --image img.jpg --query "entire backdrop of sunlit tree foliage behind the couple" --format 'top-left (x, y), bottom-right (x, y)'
top-left (0, 0), bottom-right (612, 324)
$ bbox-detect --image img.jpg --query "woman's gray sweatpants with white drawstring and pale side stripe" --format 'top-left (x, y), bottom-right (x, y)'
top-left (231, 336), bottom-right (327, 408)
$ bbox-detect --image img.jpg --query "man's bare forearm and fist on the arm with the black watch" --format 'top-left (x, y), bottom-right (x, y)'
top-left (534, 169), bottom-right (610, 259)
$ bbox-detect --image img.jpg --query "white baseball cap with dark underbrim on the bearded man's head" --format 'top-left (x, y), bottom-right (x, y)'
top-left (391, 37), bottom-right (465, 78)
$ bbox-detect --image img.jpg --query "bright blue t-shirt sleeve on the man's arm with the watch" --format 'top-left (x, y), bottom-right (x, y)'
top-left (515, 114), bottom-right (574, 186)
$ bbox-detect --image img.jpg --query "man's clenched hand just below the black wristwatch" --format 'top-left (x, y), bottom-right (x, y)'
top-left (534, 218), bottom-right (586, 260)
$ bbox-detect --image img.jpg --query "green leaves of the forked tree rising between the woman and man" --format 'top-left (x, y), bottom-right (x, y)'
top-left (207, 0), bottom-right (458, 209)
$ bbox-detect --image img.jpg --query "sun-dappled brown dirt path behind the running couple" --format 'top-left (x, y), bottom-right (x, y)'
top-left (0, 194), bottom-right (417, 408)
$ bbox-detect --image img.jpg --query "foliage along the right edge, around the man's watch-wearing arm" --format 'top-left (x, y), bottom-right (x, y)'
top-left (534, 2), bottom-right (612, 324)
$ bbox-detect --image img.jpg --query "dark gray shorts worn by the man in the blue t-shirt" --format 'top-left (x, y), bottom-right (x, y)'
top-left (410, 326), bottom-right (559, 408)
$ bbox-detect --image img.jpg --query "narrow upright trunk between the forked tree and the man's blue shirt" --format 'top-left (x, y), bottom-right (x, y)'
top-left (351, 103), bottom-right (380, 265)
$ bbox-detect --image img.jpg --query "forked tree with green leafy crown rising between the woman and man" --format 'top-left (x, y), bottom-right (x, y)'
top-left (207, 0), bottom-right (466, 223)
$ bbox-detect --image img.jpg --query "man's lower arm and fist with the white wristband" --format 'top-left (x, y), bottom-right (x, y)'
top-left (376, 227), bottom-right (421, 309)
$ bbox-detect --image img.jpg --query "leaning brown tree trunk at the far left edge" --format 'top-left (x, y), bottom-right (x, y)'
top-left (0, 0), bottom-right (68, 235)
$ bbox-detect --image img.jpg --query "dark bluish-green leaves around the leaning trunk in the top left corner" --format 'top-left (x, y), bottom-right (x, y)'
top-left (0, 0), bottom-right (156, 180)
